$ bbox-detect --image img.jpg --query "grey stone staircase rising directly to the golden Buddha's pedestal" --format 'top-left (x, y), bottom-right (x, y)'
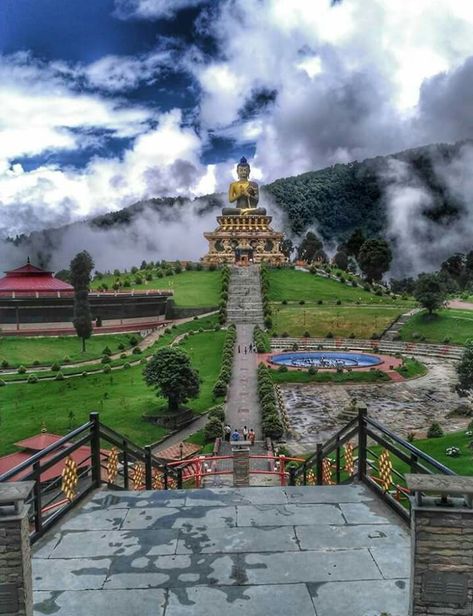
top-left (227, 265), bottom-right (264, 326)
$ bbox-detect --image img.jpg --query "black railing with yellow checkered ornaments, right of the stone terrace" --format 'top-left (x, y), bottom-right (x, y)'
top-left (290, 410), bottom-right (456, 521)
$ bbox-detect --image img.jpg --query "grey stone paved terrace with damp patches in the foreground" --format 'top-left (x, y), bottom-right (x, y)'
top-left (33, 485), bottom-right (410, 616)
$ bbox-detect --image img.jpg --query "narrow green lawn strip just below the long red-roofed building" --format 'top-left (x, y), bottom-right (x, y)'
top-left (0, 334), bottom-right (140, 368)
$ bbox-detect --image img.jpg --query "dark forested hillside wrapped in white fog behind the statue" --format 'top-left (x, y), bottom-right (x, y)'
top-left (0, 142), bottom-right (473, 276)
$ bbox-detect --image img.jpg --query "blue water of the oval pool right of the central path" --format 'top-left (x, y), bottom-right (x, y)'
top-left (270, 351), bottom-right (383, 368)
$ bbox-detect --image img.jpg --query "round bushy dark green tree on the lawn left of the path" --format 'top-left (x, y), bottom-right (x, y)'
top-left (143, 347), bottom-right (200, 413)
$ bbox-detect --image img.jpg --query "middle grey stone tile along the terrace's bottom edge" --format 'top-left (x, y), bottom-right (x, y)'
top-left (166, 584), bottom-right (316, 616)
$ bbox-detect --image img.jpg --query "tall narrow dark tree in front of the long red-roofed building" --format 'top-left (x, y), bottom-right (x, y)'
top-left (70, 250), bottom-right (94, 352)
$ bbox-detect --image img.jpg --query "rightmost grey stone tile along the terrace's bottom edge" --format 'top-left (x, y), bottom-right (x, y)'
top-left (308, 580), bottom-right (409, 616)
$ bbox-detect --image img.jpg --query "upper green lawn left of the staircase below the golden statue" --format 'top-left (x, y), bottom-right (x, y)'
top-left (91, 270), bottom-right (221, 308)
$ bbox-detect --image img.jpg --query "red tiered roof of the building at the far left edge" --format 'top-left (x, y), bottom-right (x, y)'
top-left (0, 259), bottom-right (74, 298)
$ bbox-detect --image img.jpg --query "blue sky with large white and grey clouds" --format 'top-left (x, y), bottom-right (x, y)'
top-left (0, 0), bottom-right (473, 235)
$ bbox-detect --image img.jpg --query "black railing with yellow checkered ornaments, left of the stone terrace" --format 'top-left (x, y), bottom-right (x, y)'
top-left (0, 413), bottom-right (180, 542)
